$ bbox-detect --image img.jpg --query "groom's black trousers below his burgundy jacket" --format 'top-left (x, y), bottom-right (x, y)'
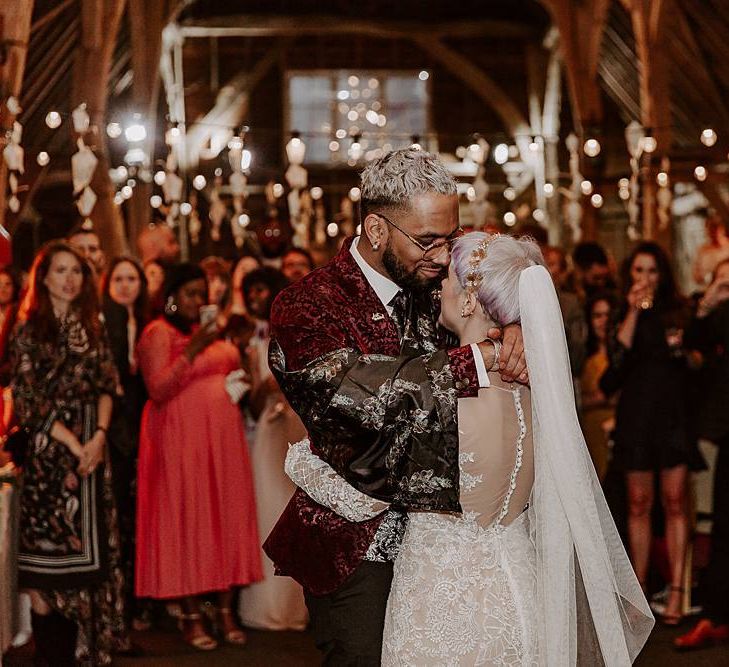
top-left (305, 560), bottom-right (392, 667)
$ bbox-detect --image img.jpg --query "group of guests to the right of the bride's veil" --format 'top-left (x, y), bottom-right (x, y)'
top-left (543, 232), bottom-right (729, 649)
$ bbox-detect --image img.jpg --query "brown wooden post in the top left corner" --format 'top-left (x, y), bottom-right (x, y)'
top-left (0, 0), bottom-right (33, 240)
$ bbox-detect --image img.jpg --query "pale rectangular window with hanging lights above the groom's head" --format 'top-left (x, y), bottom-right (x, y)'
top-left (286, 70), bottom-right (437, 167)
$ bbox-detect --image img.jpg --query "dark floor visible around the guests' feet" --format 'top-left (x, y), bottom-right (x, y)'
top-left (3, 625), bottom-right (729, 667)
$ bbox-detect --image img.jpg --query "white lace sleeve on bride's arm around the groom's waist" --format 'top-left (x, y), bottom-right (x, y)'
top-left (284, 438), bottom-right (389, 521)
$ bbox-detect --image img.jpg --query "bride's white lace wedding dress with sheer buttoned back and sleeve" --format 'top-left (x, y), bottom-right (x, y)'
top-left (287, 374), bottom-right (538, 666)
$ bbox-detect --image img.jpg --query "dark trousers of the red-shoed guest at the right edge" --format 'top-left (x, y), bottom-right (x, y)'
top-left (705, 437), bottom-right (729, 623)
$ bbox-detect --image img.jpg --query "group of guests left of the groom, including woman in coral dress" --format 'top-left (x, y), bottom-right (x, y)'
top-left (0, 226), bottom-right (313, 665)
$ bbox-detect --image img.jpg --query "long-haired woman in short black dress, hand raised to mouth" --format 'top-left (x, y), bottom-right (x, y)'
top-left (600, 242), bottom-right (702, 625)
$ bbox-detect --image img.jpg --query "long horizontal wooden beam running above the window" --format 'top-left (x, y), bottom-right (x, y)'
top-left (181, 15), bottom-right (539, 39)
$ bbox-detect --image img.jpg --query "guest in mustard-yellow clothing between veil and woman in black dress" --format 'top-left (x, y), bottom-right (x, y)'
top-left (580, 292), bottom-right (615, 482)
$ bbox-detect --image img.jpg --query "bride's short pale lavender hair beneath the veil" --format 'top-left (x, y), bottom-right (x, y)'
top-left (451, 232), bottom-right (544, 326)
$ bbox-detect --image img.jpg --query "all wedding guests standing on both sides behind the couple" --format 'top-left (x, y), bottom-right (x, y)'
top-left (0, 220), bottom-right (729, 665)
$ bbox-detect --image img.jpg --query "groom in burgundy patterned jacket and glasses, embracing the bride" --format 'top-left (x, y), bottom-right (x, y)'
top-left (264, 149), bottom-right (525, 665)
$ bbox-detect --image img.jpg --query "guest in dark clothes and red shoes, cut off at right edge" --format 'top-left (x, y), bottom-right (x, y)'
top-left (674, 259), bottom-right (729, 650)
